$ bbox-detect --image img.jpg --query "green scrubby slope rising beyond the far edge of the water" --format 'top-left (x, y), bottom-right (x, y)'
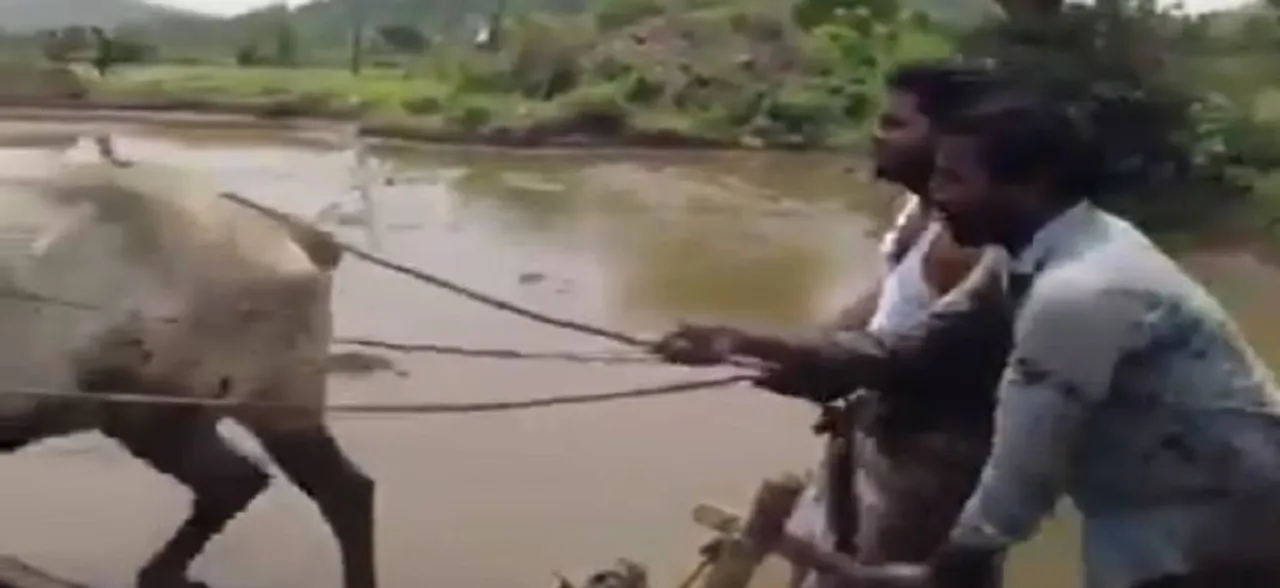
top-left (77, 0), bottom-right (952, 146)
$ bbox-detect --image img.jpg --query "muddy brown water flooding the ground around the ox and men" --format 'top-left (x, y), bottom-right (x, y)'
top-left (0, 123), bottom-right (1280, 588)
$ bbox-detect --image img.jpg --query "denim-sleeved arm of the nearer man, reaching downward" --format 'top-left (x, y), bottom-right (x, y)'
top-left (952, 281), bottom-right (1140, 551)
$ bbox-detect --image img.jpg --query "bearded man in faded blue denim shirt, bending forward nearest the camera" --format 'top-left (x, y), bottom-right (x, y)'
top-left (829, 99), bottom-right (1280, 588)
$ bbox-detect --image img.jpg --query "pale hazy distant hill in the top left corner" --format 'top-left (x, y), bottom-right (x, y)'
top-left (0, 0), bottom-right (206, 33)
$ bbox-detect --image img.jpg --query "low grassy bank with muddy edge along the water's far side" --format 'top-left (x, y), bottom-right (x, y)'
top-left (0, 65), bottom-right (860, 150)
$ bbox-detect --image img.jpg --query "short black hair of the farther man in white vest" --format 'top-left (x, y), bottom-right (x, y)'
top-left (886, 59), bottom-right (1005, 123)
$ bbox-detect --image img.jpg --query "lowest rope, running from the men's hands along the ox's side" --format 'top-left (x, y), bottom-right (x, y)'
top-left (0, 374), bottom-right (751, 415)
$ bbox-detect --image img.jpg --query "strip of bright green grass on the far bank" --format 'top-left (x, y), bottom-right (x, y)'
top-left (72, 59), bottom-right (870, 146)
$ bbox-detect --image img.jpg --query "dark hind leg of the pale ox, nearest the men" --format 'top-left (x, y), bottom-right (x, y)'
top-left (250, 423), bottom-right (378, 588)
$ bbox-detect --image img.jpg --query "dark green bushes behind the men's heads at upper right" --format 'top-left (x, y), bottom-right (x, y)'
top-left (960, 0), bottom-right (1280, 248)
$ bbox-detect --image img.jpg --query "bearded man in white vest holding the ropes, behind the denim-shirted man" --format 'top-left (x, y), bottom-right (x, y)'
top-left (658, 63), bottom-right (996, 587)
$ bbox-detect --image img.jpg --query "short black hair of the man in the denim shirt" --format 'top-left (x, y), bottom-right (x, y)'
top-left (937, 90), bottom-right (1101, 200)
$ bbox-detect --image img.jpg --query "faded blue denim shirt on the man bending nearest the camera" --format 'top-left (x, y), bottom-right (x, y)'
top-left (954, 204), bottom-right (1280, 588)
